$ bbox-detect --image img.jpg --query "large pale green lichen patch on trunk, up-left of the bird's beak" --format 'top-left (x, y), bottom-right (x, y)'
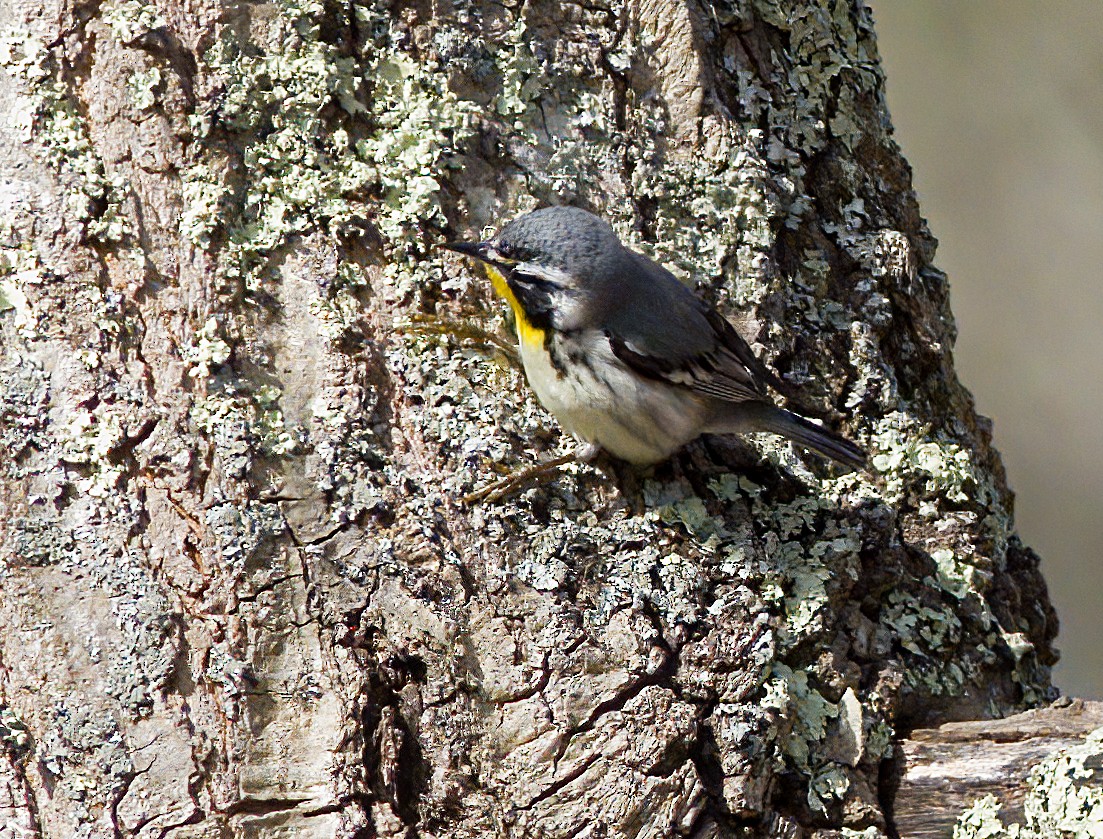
top-left (181, 0), bottom-right (473, 297)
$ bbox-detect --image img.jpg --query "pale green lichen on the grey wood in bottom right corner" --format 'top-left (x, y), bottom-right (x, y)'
top-left (954, 729), bottom-right (1103, 839)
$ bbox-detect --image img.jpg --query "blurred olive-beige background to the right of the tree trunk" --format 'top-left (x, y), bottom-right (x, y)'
top-left (867, 0), bottom-right (1103, 699)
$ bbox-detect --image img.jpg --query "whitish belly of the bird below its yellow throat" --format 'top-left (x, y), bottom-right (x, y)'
top-left (521, 332), bottom-right (705, 465)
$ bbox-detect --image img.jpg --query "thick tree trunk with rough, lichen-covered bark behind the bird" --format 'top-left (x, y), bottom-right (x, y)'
top-left (0, 0), bottom-right (1056, 837)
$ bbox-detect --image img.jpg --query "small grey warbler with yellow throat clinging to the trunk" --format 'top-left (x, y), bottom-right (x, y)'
top-left (443, 206), bottom-right (866, 467)
